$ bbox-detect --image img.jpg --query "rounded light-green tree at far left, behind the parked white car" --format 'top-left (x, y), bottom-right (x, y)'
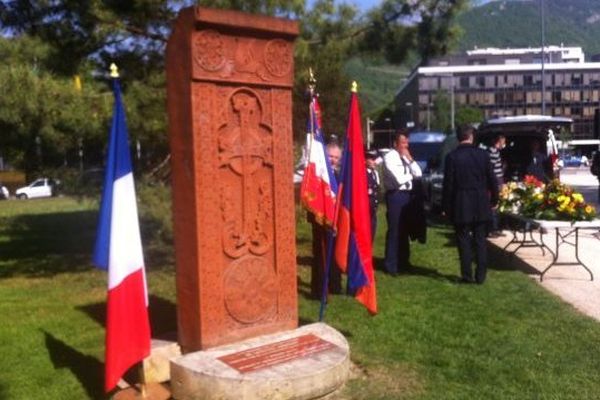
top-left (0, 37), bottom-right (109, 172)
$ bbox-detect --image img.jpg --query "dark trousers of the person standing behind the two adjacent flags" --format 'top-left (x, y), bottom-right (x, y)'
top-left (310, 222), bottom-right (342, 299)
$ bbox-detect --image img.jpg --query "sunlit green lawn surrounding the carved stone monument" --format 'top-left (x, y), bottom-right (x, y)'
top-left (0, 198), bottom-right (600, 399)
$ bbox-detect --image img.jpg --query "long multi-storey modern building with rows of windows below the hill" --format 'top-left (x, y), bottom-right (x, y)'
top-left (395, 45), bottom-right (600, 140)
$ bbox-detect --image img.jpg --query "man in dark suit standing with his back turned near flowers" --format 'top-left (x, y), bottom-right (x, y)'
top-left (442, 126), bottom-right (498, 284)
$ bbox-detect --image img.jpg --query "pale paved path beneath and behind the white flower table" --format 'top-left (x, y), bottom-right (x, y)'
top-left (490, 168), bottom-right (600, 321)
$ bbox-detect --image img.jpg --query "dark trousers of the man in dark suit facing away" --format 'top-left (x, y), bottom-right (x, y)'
top-left (454, 221), bottom-right (487, 283)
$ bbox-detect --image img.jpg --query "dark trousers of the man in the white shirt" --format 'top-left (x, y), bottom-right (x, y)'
top-left (384, 190), bottom-right (410, 274)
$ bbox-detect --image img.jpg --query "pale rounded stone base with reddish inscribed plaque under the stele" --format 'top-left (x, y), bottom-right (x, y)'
top-left (171, 323), bottom-right (350, 400)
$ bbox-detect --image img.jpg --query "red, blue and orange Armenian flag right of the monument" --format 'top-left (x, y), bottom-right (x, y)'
top-left (335, 87), bottom-right (377, 314)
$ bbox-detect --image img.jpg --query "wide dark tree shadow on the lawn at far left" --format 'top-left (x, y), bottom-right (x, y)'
top-left (0, 211), bottom-right (97, 278)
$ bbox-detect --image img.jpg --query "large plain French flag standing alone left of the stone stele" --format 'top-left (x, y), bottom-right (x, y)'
top-left (93, 70), bottom-right (150, 392)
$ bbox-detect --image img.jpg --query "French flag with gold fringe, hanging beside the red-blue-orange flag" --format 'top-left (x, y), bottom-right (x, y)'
top-left (300, 96), bottom-right (337, 226)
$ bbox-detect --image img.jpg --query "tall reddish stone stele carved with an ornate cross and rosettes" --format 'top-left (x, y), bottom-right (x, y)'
top-left (167, 4), bottom-right (298, 352)
